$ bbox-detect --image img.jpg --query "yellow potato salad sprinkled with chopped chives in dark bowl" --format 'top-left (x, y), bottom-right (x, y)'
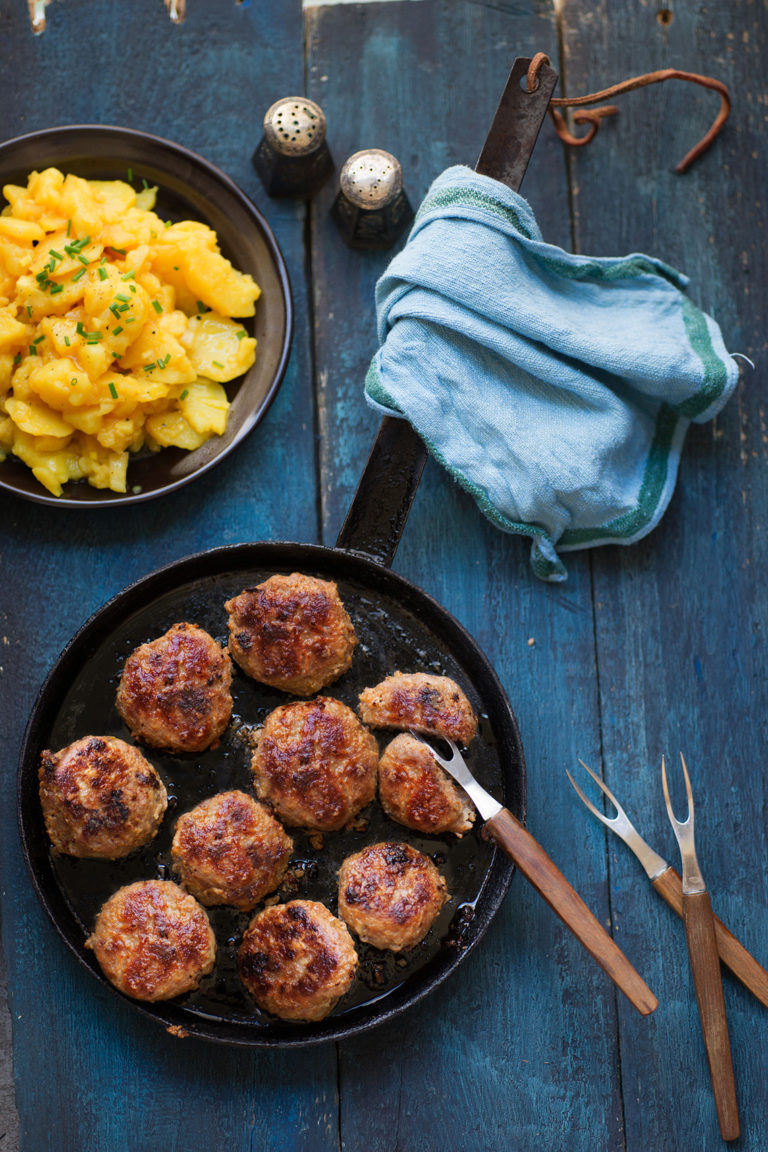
top-left (0, 168), bottom-right (260, 495)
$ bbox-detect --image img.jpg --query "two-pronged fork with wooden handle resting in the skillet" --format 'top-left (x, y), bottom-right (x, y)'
top-left (411, 732), bottom-right (659, 1016)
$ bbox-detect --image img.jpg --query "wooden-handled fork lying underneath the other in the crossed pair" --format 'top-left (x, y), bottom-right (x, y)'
top-left (565, 760), bottom-right (768, 1008)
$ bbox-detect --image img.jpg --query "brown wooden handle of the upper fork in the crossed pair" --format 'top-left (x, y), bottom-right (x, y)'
top-left (683, 892), bottom-right (739, 1140)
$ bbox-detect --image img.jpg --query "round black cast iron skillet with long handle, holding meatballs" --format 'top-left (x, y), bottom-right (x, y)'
top-left (18, 61), bottom-right (556, 1046)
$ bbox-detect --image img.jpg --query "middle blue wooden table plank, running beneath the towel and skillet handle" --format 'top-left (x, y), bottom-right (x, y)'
top-left (307, 0), bottom-right (647, 1152)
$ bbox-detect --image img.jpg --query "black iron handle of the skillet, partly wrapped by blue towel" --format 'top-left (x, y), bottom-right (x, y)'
top-left (336, 58), bottom-right (557, 568)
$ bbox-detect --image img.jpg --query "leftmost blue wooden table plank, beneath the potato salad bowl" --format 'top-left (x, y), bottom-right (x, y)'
top-left (0, 0), bottom-right (337, 1152)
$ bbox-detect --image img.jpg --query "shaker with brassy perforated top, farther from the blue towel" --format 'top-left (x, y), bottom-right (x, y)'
top-left (253, 96), bottom-right (333, 197)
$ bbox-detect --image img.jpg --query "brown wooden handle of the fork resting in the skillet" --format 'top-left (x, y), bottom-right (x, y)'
top-left (485, 808), bottom-right (659, 1016)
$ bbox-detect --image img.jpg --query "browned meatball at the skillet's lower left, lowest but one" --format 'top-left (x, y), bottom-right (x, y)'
top-left (85, 880), bottom-right (216, 1000)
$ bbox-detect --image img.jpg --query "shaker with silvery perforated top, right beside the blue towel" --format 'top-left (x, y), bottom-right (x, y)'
top-left (332, 147), bottom-right (413, 249)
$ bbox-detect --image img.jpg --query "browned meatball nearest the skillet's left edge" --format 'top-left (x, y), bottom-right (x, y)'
top-left (38, 736), bottom-right (168, 861)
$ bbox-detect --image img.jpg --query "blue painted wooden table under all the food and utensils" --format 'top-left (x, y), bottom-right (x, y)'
top-left (0, 0), bottom-right (768, 1152)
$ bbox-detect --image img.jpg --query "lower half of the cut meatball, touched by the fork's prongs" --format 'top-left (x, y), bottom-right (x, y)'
top-left (379, 733), bottom-right (474, 836)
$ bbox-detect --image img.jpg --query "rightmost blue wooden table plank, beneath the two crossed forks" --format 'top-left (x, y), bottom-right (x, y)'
top-left (563, 0), bottom-right (768, 1152)
